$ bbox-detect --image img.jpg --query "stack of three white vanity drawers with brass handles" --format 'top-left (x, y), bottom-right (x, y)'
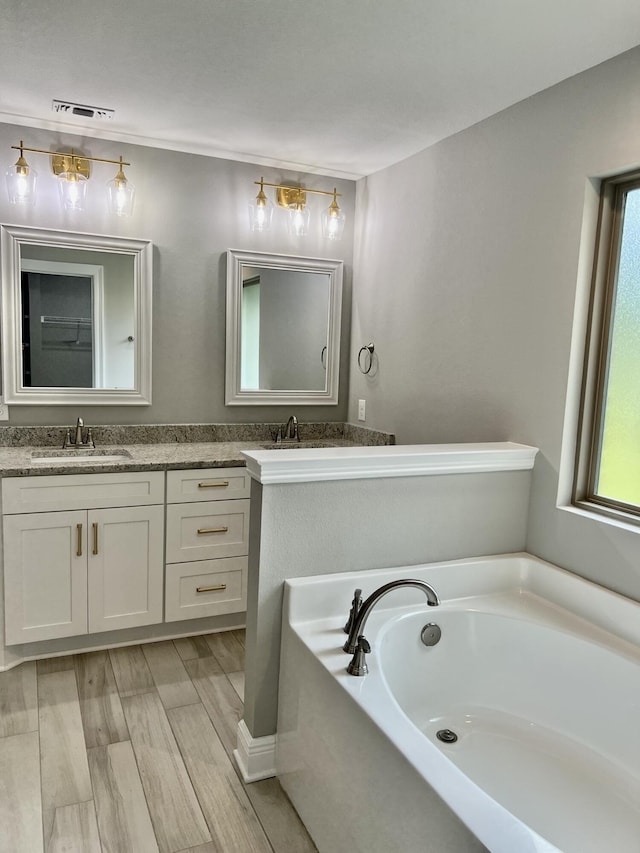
top-left (165, 468), bottom-right (250, 622)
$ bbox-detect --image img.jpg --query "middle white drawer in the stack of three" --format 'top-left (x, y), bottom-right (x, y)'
top-left (167, 500), bottom-right (250, 563)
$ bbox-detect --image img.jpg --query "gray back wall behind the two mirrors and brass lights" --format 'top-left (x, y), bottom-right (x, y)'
top-left (0, 124), bottom-right (355, 424)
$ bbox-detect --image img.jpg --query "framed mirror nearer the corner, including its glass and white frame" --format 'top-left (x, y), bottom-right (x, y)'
top-left (225, 249), bottom-right (342, 406)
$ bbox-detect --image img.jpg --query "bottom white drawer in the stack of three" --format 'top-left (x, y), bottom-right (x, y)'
top-left (164, 557), bottom-right (248, 622)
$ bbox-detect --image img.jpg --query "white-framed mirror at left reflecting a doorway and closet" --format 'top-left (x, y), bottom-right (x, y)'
top-left (0, 225), bottom-right (152, 406)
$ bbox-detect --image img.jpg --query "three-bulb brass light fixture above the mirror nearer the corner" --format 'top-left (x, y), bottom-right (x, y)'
top-left (249, 178), bottom-right (345, 240)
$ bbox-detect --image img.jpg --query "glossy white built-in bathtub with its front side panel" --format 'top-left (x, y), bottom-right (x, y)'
top-left (276, 554), bottom-right (640, 853)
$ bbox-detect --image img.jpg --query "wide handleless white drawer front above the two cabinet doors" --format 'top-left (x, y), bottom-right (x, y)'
top-left (2, 471), bottom-right (164, 515)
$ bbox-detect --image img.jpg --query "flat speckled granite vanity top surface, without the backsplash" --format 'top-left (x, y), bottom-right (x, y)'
top-left (0, 438), bottom-right (358, 477)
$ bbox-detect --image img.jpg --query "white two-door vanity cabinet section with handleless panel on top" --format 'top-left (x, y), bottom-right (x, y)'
top-left (2, 471), bottom-right (164, 645)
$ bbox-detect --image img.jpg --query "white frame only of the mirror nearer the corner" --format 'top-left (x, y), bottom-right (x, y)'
top-left (225, 249), bottom-right (343, 406)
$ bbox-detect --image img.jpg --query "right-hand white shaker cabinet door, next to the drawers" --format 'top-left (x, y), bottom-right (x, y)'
top-left (88, 506), bottom-right (164, 633)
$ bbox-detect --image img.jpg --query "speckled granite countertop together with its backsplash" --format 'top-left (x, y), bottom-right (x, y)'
top-left (0, 423), bottom-right (394, 477)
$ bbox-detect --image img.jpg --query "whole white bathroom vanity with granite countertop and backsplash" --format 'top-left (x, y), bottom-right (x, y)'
top-left (0, 424), bottom-right (388, 670)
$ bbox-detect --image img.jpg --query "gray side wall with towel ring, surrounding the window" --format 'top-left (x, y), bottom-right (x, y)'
top-left (349, 49), bottom-right (640, 599)
